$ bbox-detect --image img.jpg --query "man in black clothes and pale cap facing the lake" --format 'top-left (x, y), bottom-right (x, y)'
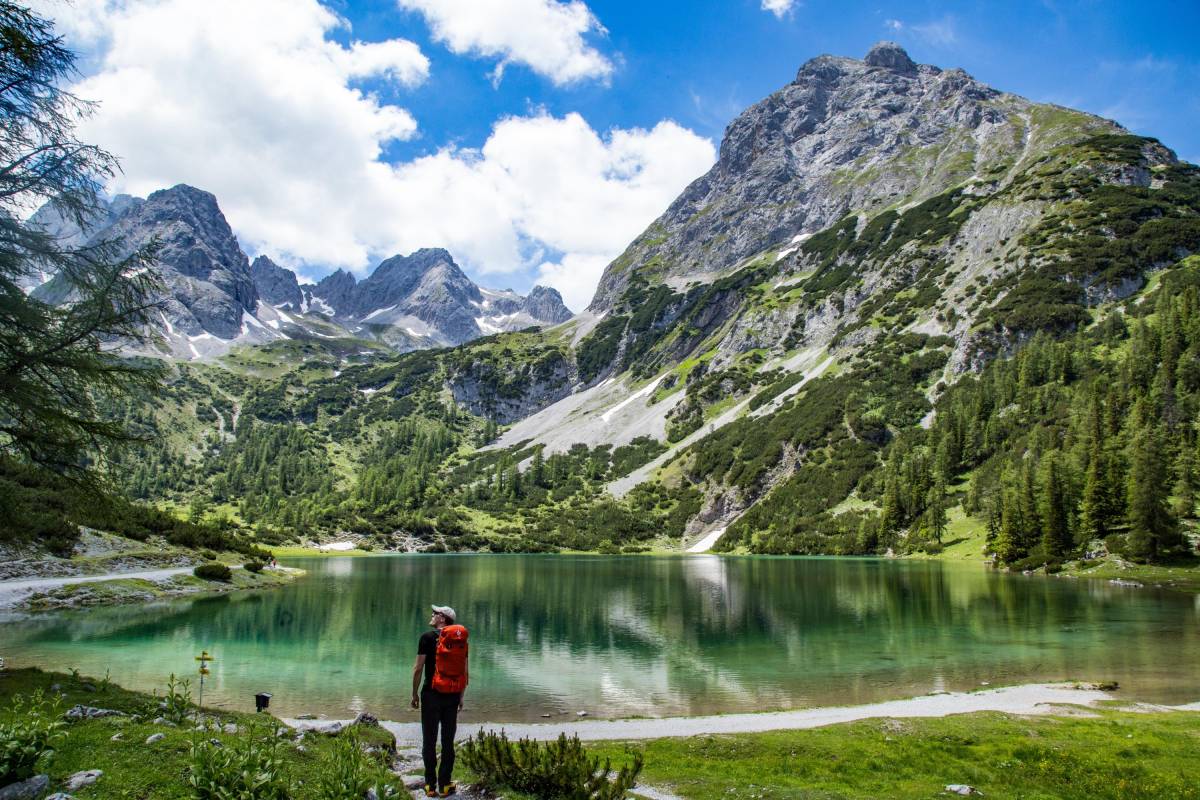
top-left (413, 606), bottom-right (468, 798)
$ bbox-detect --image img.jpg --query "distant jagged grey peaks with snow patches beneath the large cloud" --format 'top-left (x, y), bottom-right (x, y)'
top-left (31, 185), bottom-right (571, 359)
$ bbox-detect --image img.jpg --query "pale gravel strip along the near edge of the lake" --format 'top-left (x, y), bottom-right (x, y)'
top-left (280, 684), bottom-right (1200, 745)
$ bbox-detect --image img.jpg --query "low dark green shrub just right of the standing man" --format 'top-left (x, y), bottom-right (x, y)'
top-left (462, 730), bottom-right (642, 800)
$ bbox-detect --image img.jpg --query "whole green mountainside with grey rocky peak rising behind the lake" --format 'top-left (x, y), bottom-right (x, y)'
top-left (9, 46), bottom-right (1200, 569)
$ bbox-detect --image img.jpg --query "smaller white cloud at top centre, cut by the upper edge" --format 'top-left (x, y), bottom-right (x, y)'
top-left (397, 0), bottom-right (613, 85)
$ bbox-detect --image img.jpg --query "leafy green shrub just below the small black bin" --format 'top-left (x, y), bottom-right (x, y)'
top-left (187, 729), bottom-right (292, 800)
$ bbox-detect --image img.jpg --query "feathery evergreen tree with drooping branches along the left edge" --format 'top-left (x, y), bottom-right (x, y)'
top-left (0, 0), bottom-right (162, 477)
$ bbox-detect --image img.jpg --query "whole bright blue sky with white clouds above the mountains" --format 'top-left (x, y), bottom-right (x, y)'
top-left (37, 0), bottom-right (1200, 309)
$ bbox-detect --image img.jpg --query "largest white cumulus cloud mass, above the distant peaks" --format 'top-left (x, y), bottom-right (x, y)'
top-left (35, 0), bottom-right (715, 309)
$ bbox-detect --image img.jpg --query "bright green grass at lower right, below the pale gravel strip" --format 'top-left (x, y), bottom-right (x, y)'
top-left (589, 710), bottom-right (1200, 800)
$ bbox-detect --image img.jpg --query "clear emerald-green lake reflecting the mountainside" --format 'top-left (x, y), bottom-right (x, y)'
top-left (0, 555), bottom-right (1200, 722)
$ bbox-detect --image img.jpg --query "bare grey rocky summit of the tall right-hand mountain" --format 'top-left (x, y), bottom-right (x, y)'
top-left (589, 42), bottom-right (1118, 314)
